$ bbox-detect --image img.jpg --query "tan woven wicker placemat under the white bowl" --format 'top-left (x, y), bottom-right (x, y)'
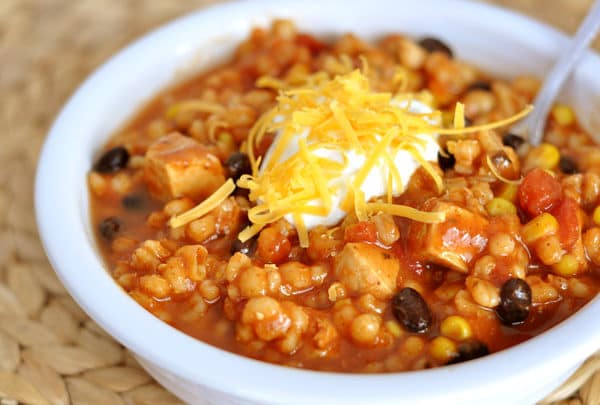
top-left (0, 0), bottom-right (600, 405)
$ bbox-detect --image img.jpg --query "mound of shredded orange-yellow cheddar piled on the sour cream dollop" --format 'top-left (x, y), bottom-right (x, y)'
top-left (237, 69), bottom-right (458, 247)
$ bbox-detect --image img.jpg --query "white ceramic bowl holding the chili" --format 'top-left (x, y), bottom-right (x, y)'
top-left (36, 0), bottom-right (600, 405)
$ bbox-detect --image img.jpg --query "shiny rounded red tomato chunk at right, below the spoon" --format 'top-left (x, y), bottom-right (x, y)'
top-left (518, 169), bottom-right (562, 217)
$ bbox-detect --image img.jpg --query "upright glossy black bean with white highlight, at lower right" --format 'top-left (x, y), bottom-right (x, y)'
top-left (496, 278), bottom-right (531, 326)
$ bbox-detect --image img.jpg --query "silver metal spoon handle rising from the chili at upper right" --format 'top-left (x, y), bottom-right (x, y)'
top-left (527, 0), bottom-right (600, 145)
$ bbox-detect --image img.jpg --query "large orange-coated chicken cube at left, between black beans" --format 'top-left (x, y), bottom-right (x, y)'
top-left (144, 132), bottom-right (225, 201)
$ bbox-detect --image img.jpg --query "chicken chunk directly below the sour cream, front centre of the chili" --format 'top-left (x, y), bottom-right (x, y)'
top-left (335, 243), bottom-right (400, 300)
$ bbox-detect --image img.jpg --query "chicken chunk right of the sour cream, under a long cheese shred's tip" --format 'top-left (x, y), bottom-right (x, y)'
top-left (409, 201), bottom-right (488, 273)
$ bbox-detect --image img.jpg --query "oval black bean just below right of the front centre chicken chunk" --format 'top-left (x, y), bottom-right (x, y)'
top-left (392, 287), bottom-right (432, 333)
